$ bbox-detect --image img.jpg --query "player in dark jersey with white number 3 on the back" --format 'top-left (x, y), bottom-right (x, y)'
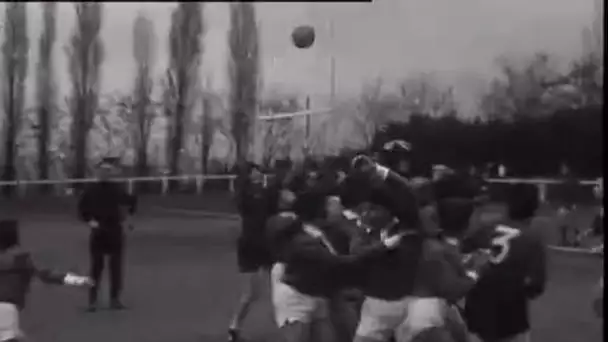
top-left (464, 184), bottom-right (547, 342)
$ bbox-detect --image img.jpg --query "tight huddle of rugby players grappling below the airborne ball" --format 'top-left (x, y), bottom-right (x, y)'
top-left (233, 143), bottom-right (546, 342)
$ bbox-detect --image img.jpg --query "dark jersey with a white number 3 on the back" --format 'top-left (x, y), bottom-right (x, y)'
top-left (464, 223), bottom-right (546, 339)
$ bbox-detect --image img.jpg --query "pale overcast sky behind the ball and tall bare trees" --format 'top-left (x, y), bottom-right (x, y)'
top-left (11, 0), bottom-right (596, 115)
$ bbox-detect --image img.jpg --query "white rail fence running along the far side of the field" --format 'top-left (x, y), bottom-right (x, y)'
top-left (0, 174), bottom-right (600, 203)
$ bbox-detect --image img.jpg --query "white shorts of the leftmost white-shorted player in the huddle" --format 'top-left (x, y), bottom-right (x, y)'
top-left (270, 263), bottom-right (328, 328)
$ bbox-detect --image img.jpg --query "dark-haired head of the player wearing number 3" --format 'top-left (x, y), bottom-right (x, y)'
top-left (507, 183), bottom-right (539, 221)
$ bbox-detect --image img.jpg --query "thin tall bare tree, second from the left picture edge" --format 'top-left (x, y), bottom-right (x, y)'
top-left (36, 2), bottom-right (57, 191)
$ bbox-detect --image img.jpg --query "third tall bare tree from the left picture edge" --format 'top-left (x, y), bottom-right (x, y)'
top-left (66, 2), bottom-right (104, 178)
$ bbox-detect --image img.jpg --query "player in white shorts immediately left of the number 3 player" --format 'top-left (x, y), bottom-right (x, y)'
top-left (404, 197), bottom-right (489, 342)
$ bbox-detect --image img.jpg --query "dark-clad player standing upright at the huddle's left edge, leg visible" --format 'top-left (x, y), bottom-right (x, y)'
top-left (228, 163), bottom-right (278, 342)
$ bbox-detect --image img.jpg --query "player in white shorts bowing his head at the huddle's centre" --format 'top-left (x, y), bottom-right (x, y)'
top-left (345, 152), bottom-right (440, 342)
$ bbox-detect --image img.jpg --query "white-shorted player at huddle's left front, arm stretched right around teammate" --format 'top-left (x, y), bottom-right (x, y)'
top-left (272, 191), bottom-right (401, 342)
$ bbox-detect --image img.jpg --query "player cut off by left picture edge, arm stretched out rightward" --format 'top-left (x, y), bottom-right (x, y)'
top-left (0, 220), bottom-right (93, 342)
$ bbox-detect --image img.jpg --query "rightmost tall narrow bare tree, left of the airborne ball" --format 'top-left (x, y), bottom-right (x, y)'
top-left (228, 2), bottom-right (260, 164)
